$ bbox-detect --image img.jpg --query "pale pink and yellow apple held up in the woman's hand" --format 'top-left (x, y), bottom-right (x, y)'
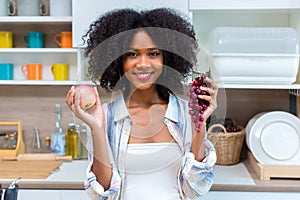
top-left (75, 84), bottom-right (96, 110)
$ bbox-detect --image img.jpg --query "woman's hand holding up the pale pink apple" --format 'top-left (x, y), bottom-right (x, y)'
top-left (66, 86), bottom-right (105, 130)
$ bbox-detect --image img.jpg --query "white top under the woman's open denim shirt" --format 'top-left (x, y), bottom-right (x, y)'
top-left (122, 143), bottom-right (182, 200)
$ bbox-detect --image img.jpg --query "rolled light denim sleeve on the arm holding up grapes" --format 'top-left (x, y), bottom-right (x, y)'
top-left (180, 139), bottom-right (216, 199)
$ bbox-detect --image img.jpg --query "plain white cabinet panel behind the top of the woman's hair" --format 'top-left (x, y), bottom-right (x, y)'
top-left (72, 0), bottom-right (189, 47)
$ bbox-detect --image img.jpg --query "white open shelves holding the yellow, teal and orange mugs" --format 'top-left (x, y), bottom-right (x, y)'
top-left (0, 16), bottom-right (78, 85)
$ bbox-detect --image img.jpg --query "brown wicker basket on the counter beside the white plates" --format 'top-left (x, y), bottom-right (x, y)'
top-left (207, 124), bottom-right (245, 165)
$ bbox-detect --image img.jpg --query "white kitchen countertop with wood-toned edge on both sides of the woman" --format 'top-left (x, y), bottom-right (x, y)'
top-left (0, 160), bottom-right (300, 195)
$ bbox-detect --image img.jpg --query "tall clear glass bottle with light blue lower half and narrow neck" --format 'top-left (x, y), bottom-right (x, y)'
top-left (50, 104), bottom-right (66, 156)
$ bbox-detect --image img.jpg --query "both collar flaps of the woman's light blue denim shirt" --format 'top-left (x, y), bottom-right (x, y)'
top-left (113, 91), bottom-right (180, 122)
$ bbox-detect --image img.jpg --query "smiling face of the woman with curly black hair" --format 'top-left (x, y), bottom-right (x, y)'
top-left (123, 31), bottom-right (163, 90)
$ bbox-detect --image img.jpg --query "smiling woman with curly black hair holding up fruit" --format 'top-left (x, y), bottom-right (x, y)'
top-left (67, 8), bottom-right (218, 200)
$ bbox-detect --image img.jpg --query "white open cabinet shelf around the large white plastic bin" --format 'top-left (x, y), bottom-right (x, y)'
top-left (189, 0), bottom-right (300, 89)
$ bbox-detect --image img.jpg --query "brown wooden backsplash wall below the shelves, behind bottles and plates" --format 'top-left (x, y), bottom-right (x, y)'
top-left (0, 85), bottom-right (289, 152)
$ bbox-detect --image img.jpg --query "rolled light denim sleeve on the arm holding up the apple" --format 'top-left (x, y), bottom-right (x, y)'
top-left (84, 156), bottom-right (121, 200)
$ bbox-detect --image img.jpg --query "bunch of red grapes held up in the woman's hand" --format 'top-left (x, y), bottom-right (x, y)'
top-left (188, 74), bottom-right (209, 133)
